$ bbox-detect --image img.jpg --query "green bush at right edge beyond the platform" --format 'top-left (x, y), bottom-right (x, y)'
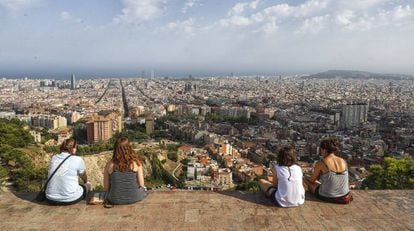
top-left (363, 157), bottom-right (414, 189)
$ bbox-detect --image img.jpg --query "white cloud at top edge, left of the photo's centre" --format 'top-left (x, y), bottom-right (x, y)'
top-left (113, 0), bottom-right (164, 23)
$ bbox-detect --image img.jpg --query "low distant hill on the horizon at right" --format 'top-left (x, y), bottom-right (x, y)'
top-left (302, 70), bottom-right (414, 80)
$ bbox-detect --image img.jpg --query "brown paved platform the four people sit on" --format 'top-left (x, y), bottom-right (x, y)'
top-left (0, 190), bottom-right (414, 231)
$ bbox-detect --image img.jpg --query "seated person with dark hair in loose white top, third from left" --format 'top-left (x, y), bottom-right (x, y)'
top-left (259, 147), bottom-right (305, 207)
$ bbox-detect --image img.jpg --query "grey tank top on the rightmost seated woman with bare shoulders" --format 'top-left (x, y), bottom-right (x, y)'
top-left (318, 160), bottom-right (349, 197)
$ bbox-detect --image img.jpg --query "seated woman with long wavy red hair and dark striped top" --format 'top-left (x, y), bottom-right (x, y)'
top-left (104, 137), bottom-right (147, 204)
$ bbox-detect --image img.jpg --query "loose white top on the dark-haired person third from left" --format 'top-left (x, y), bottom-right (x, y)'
top-left (275, 164), bottom-right (305, 207)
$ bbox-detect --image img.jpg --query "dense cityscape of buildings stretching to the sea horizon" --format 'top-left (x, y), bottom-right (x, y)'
top-left (0, 73), bottom-right (414, 190)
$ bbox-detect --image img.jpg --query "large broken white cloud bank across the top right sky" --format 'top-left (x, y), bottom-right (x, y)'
top-left (215, 0), bottom-right (414, 34)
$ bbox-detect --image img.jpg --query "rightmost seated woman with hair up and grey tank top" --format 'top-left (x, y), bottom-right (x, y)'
top-left (304, 138), bottom-right (349, 202)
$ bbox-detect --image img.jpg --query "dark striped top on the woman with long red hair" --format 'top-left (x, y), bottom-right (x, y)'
top-left (107, 171), bottom-right (147, 205)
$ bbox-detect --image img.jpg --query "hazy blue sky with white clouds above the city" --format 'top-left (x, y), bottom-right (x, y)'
top-left (0, 0), bottom-right (414, 77)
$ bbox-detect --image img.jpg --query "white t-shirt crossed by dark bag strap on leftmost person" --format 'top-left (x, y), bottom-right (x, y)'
top-left (46, 152), bottom-right (85, 202)
